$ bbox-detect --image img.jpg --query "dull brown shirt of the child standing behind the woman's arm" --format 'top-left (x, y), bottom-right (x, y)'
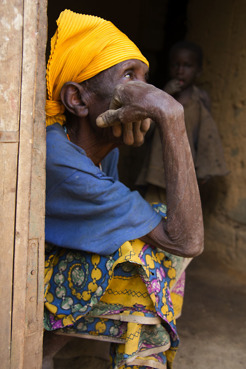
top-left (136, 86), bottom-right (228, 188)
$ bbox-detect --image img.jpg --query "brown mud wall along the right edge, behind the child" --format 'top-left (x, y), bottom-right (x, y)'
top-left (186, 0), bottom-right (246, 271)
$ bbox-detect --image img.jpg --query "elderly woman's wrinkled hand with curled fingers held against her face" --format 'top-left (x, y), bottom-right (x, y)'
top-left (97, 81), bottom-right (183, 146)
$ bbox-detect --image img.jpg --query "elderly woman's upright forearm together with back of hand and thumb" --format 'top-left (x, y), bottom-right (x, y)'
top-left (97, 81), bottom-right (203, 257)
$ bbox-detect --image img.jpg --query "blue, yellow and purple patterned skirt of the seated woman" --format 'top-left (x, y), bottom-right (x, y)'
top-left (44, 204), bottom-right (191, 369)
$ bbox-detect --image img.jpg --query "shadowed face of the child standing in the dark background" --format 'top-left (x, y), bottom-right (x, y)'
top-left (170, 49), bottom-right (201, 90)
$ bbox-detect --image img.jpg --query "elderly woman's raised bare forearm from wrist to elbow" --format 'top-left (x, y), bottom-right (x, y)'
top-left (146, 100), bottom-right (203, 257)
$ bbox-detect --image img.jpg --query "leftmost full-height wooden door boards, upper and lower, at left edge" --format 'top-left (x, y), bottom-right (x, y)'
top-left (0, 0), bottom-right (22, 369)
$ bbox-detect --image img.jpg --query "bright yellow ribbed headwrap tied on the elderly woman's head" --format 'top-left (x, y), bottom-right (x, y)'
top-left (45, 9), bottom-right (149, 126)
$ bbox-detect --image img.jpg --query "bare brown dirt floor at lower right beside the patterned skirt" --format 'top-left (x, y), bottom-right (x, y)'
top-left (174, 255), bottom-right (246, 369)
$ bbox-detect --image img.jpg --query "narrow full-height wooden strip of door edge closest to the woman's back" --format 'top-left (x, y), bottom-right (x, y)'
top-left (24, 1), bottom-right (47, 368)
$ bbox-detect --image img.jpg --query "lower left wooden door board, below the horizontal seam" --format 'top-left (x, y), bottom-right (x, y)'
top-left (0, 143), bottom-right (18, 368)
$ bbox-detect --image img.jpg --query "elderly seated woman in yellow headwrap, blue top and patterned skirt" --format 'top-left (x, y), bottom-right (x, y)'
top-left (44, 10), bottom-right (203, 369)
